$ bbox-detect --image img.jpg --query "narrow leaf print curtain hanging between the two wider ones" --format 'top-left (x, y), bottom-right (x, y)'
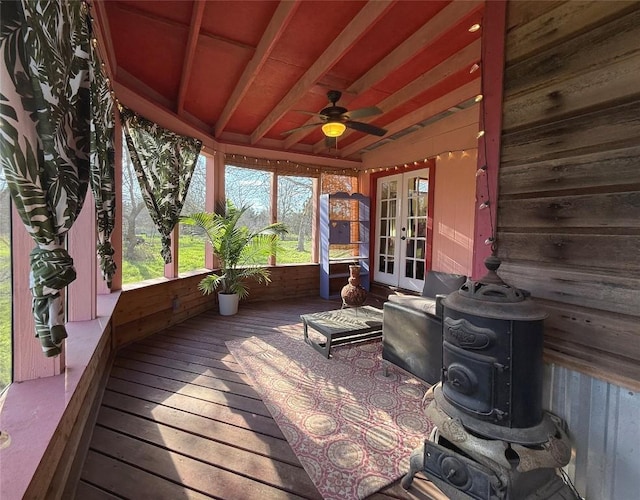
top-left (90, 44), bottom-right (116, 288)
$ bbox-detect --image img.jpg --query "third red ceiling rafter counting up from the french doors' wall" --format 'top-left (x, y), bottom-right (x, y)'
top-left (284, 0), bottom-right (484, 149)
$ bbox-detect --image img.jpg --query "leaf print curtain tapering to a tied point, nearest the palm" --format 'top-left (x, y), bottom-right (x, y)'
top-left (120, 107), bottom-right (202, 264)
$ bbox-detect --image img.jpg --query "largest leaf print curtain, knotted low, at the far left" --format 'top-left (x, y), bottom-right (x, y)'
top-left (0, 0), bottom-right (90, 356)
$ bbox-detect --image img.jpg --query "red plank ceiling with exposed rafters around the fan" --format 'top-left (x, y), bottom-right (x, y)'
top-left (92, 0), bottom-right (484, 160)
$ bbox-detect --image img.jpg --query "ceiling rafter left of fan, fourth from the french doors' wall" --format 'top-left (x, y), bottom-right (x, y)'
top-left (251, 0), bottom-right (395, 144)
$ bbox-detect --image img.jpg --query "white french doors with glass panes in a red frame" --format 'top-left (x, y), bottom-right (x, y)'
top-left (373, 168), bottom-right (429, 292)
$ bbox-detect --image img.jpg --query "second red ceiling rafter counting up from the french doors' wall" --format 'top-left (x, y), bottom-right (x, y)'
top-left (313, 38), bottom-right (482, 153)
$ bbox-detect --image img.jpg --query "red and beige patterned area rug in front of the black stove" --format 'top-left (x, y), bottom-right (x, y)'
top-left (227, 334), bottom-right (431, 500)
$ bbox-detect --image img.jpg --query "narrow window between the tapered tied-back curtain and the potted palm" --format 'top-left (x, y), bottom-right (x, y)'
top-left (178, 155), bottom-right (207, 273)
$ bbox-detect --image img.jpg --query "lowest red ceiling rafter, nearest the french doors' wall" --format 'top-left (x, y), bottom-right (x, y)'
top-left (340, 75), bottom-right (480, 158)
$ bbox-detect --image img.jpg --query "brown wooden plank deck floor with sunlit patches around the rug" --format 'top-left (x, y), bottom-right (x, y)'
top-left (76, 299), bottom-right (444, 500)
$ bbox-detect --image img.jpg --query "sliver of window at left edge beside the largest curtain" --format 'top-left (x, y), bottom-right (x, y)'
top-left (0, 168), bottom-right (13, 392)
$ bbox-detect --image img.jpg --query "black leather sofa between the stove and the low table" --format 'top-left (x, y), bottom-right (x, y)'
top-left (382, 271), bottom-right (467, 384)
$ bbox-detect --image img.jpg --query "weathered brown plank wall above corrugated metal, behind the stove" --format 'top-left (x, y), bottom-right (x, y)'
top-left (498, 1), bottom-right (640, 390)
